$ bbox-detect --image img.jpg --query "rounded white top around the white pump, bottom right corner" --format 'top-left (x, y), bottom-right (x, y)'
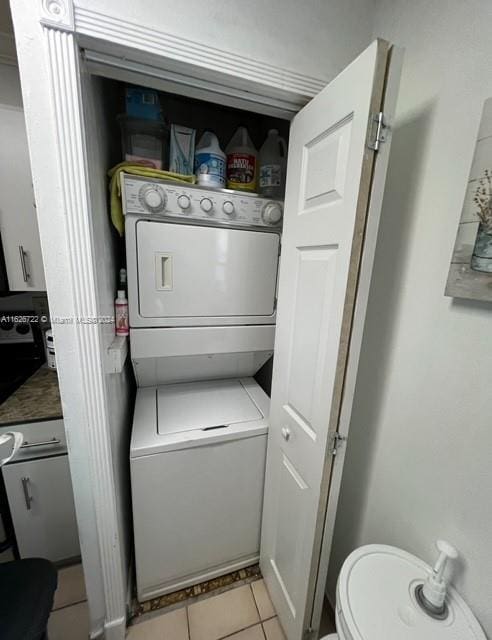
top-left (337, 545), bottom-right (486, 640)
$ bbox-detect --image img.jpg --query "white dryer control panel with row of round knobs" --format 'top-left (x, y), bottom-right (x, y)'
top-left (122, 174), bottom-right (283, 228)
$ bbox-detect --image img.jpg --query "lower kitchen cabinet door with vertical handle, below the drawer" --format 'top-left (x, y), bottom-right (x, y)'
top-left (2, 456), bottom-right (80, 562)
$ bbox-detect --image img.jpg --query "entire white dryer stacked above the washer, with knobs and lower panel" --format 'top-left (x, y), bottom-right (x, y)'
top-left (122, 174), bottom-right (282, 387)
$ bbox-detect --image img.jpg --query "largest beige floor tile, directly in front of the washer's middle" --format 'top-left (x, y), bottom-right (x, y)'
top-left (188, 585), bottom-right (260, 640)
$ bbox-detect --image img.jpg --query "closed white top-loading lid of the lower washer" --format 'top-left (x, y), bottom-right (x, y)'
top-left (157, 379), bottom-right (264, 435)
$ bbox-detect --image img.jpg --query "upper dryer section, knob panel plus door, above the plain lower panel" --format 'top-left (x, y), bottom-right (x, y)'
top-left (122, 175), bottom-right (282, 329)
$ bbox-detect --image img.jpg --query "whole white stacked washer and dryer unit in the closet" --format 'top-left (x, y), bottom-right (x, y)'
top-left (122, 175), bottom-right (282, 601)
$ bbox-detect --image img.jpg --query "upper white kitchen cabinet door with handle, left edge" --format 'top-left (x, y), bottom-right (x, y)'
top-left (0, 105), bottom-right (46, 291)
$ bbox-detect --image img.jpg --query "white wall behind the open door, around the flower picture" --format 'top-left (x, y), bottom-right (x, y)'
top-left (328, 0), bottom-right (492, 637)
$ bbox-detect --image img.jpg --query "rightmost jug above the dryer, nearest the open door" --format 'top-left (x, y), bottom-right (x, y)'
top-left (259, 129), bottom-right (287, 198)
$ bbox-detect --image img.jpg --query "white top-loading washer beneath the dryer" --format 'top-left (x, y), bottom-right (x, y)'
top-left (130, 378), bottom-right (269, 601)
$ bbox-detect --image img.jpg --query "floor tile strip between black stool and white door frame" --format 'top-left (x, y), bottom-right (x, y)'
top-left (48, 564), bottom-right (89, 640)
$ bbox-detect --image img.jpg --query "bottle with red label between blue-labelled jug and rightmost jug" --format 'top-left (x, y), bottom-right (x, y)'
top-left (226, 127), bottom-right (258, 191)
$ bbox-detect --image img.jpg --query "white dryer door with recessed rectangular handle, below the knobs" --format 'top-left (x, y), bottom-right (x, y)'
top-left (136, 220), bottom-right (280, 326)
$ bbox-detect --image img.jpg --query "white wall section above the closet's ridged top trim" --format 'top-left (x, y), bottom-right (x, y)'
top-left (76, 0), bottom-right (374, 79)
